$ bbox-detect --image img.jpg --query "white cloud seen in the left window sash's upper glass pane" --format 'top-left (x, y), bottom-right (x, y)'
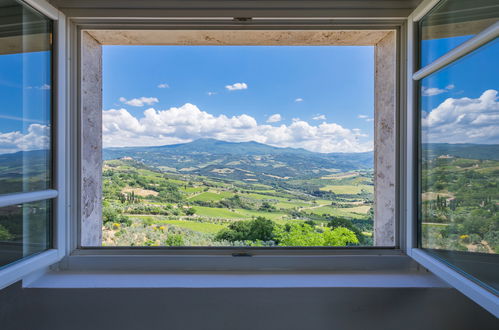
top-left (0, 124), bottom-right (50, 154)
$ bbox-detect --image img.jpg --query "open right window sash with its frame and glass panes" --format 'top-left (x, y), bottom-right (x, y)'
top-left (409, 0), bottom-right (499, 316)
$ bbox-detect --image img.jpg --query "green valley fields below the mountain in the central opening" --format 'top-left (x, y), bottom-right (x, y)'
top-left (103, 157), bottom-right (373, 246)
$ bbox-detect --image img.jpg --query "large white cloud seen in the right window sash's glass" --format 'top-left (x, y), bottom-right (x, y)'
top-left (421, 89), bottom-right (499, 143)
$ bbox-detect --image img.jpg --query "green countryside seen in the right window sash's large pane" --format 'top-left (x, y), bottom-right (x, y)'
top-left (421, 151), bottom-right (499, 253)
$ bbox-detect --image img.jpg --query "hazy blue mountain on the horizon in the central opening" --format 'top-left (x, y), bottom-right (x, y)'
top-left (103, 139), bottom-right (373, 181)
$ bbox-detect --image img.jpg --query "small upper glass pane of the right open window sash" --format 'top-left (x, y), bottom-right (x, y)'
top-left (420, 0), bottom-right (499, 67)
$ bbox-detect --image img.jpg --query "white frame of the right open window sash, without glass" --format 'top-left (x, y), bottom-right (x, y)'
top-left (405, 0), bottom-right (499, 317)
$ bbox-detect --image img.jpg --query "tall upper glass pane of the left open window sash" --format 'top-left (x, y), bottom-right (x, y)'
top-left (0, 0), bottom-right (52, 194)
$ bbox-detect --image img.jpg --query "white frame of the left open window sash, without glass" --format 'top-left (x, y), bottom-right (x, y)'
top-left (0, 0), bottom-right (68, 289)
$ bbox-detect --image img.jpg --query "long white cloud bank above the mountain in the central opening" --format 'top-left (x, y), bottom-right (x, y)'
top-left (103, 103), bottom-right (373, 152)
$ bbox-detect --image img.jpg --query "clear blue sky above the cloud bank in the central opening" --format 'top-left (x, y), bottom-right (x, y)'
top-left (103, 46), bottom-right (374, 134)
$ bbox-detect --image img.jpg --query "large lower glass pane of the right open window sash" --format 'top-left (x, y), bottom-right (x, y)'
top-left (420, 39), bottom-right (499, 289)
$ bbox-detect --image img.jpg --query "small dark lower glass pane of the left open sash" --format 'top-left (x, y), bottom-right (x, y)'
top-left (0, 200), bottom-right (52, 267)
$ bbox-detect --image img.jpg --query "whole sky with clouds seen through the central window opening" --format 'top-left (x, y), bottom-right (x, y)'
top-left (103, 46), bottom-right (374, 152)
